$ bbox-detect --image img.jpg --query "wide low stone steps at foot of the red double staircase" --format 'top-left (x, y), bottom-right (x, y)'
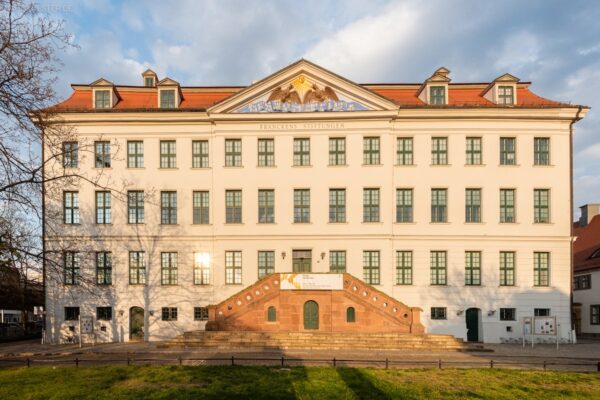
top-left (161, 331), bottom-right (482, 351)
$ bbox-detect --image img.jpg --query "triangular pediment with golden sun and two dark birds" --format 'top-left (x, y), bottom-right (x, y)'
top-left (208, 60), bottom-right (397, 114)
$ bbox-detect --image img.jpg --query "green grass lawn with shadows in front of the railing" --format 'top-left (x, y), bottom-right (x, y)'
top-left (0, 366), bottom-right (600, 400)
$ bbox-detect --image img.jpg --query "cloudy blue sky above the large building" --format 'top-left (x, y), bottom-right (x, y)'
top-left (38, 0), bottom-right (600, 214)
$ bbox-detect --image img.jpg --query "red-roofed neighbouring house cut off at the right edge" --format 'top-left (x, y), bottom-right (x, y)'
top-left (573, 204), bottom-right (600, 336)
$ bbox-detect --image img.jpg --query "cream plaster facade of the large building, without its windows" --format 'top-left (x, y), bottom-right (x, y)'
top-left (46, 60), bottom-right (588, 342)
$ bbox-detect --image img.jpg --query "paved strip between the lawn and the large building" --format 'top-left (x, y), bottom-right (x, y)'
top-left (0, 341), bottom-right (600, 371)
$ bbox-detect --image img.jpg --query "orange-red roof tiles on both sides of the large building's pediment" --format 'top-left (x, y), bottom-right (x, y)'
top-left (55, 83), bottom-right (573, 111)
